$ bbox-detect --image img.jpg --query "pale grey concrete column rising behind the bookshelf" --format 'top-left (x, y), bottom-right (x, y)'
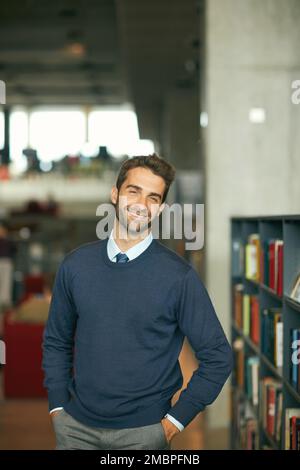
top-left (202, 0), bottom-right (300, 434)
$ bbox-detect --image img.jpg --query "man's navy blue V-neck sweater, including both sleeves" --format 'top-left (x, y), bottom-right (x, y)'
top-left (43, 239), bottom-right (232, 428)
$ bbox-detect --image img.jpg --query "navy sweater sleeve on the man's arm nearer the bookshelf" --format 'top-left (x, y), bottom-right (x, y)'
top-left (168, 267), bottom-right (233, 426)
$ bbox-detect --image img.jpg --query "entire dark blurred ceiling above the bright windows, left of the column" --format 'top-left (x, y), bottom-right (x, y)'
top-left (0, 0), bottom-right (204, 138)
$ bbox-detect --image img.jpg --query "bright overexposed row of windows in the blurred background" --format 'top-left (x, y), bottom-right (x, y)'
top-left (6, 106), bottom-right (154, 172)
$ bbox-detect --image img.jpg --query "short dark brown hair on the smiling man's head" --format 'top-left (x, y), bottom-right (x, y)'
top-left (116, 153), bottom-right (176, 203)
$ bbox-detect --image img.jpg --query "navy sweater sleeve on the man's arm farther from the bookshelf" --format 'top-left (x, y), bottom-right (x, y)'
top-left (42, 261), bottom-right (77, 410)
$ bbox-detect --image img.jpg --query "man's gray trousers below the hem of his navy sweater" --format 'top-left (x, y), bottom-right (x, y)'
top-left (52, 409), bottom-right (170, 450)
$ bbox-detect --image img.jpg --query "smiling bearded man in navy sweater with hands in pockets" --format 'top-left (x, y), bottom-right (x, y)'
top-left (43, 154), bottom-right (232, 450)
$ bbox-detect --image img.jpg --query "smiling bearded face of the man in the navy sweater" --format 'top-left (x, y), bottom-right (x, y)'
top-left (111, 168), bottom-right (165, 235)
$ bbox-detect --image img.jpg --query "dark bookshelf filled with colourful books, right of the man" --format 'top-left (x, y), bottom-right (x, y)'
top-left (230, 215), bottom-right (300, 450)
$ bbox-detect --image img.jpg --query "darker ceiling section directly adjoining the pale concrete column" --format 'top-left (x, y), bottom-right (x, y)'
top-left (116, 0), bottom-right (204, 139)
